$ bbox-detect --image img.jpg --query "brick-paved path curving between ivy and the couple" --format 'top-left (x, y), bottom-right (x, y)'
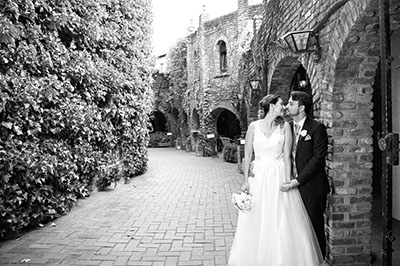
top-left (0, 148), bottom-right (242, 265)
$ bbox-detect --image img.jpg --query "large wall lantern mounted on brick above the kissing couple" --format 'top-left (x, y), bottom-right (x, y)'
top-left (281, 30), bottom-right (321, 62)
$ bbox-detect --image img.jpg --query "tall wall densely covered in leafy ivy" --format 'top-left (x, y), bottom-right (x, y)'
top-left (0, 0), bottom-right (153, 238)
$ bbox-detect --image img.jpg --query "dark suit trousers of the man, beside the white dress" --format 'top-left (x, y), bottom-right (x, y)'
top-left (302, 195), bottom-right (327, 258)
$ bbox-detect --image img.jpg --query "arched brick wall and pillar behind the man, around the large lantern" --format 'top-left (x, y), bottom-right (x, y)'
top-left (247, 0), bottom-right (400, 265)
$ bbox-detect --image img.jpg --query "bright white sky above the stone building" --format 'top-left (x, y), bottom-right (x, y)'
top-left (152, 0), bottom-right (237, 56)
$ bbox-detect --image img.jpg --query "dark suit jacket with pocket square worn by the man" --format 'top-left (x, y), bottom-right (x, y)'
top-left (292, 117), bottom-right (330, 197)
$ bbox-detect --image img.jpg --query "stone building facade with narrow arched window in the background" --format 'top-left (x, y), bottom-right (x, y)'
top-left (187, 0), bottom-right (262, 137)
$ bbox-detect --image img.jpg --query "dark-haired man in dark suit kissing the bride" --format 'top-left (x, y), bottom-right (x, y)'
top-left (281, 91), bottom-right (330, 257)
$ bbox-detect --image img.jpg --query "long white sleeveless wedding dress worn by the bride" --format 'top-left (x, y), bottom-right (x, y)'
top-left (228, 121), bottom-right (322, 266)
